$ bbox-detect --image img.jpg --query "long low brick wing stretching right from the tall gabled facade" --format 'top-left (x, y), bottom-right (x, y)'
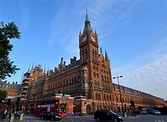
top-left (113, 83), bottom-right (165, 112)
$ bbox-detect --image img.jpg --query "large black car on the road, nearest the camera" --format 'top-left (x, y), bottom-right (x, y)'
top-left (94, 110), bottom-right (123, 122)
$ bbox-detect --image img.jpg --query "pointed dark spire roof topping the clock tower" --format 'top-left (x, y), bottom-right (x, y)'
top-left (83, 10), bottom-right (92, 34)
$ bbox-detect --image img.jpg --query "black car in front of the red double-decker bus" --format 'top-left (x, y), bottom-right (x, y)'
top-left (41, 112), bottom-right (62, 121)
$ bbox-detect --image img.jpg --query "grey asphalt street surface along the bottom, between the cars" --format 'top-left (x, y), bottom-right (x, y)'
top-left (3, 115), bottom-right (167, 122)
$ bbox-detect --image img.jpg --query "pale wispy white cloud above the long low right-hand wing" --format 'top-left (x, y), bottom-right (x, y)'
top-left (112, 40), bottom-right (167, 99)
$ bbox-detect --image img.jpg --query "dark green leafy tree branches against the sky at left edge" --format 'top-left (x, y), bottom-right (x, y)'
top-left (0, 22), bottom-right (20, 80)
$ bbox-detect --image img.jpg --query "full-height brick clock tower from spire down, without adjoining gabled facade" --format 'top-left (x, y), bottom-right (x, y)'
top-left (79, 12), bottom-right (99, 99)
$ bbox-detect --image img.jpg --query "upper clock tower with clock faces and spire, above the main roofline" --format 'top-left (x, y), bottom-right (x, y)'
top-left (79, 13), bottom-right (98, 64)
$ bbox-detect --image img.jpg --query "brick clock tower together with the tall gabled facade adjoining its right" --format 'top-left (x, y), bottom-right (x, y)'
top-left (79, 12), bottom-right (113, 110)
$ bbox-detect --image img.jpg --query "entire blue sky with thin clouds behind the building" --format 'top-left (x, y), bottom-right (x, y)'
top-left (0, 0), bottom-right (167, 99)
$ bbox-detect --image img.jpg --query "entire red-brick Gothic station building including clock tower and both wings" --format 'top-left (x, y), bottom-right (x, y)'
top-left (5, 11), bottom-right (165, 114)
